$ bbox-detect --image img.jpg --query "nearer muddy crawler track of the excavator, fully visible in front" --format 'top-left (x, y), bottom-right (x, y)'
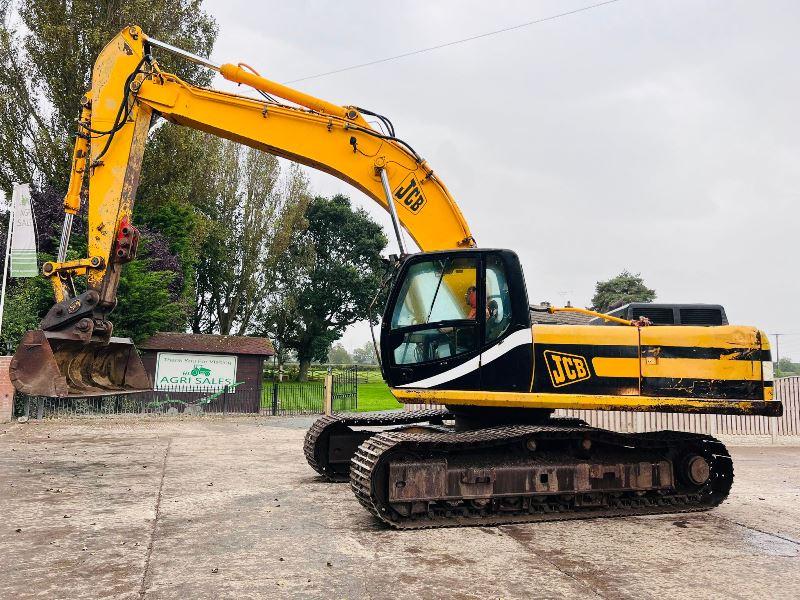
top-left (350, 419), bottom-right (733, 529)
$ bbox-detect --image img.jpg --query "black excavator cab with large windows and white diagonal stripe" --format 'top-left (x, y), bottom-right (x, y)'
top-left (381, 248), bottom-right (531, 391)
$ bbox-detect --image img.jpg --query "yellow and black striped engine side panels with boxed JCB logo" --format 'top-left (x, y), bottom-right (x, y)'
top-left (532, 325), bottom-right (771, 400)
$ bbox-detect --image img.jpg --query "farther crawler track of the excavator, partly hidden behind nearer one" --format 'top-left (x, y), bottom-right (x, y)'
top-left (303, 409), bottom-right (453, 483)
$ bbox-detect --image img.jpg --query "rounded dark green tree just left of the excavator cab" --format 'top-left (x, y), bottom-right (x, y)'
top-left (263, 195), bottom-right (387, 381)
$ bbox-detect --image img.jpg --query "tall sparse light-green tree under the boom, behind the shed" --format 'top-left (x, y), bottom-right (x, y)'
top-left (192, 141), bottom-right (310, 335)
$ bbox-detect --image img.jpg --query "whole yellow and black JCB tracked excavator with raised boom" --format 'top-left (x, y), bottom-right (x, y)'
top-left (11, 26), bottom-right (782, 528)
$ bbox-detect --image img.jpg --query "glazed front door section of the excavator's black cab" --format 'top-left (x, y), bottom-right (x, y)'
top-left (381, 250), bottom-right (485, 390)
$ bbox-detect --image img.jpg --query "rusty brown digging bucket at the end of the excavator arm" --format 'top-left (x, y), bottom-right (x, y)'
top-left (10, 329), bottom-right (152, 398)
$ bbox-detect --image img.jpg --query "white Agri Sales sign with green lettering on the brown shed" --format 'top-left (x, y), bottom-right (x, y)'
top-left (155, 352), bottom-right (236, 392)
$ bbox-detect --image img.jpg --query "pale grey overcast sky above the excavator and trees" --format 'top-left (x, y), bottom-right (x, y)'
top-left (205, 0), bottom-right (800, 359)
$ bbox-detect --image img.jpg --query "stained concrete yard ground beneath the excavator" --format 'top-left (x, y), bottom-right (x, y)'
top-left (0, 418), bottom-right (800, 599)
